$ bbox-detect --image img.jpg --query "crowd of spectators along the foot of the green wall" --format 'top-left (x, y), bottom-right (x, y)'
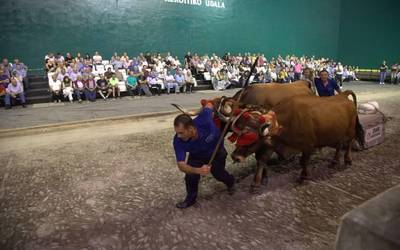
top-left (0, 51), bottom-right (400, 108)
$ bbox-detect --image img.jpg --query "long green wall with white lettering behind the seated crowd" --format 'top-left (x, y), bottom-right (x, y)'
top-left (0, 0), bottom-right (340, 68)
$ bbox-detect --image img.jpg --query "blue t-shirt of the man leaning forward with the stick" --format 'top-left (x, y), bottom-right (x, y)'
top-left (173, 108), bottom-right (220, 162)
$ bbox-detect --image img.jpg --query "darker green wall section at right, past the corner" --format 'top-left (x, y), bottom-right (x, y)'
top-left (338, 0), bottom-right (400, 68)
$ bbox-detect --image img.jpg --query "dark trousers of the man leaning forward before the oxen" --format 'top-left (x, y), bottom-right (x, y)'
top-left (185, 146), bottom-right (235, 203)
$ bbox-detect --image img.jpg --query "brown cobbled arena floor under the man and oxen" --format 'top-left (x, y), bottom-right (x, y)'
top-left (0, 83), bottom-right (400, 250)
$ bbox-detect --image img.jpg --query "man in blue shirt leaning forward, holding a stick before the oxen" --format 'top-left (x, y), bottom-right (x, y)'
top-left (173, 103), bottom-right (235, 209)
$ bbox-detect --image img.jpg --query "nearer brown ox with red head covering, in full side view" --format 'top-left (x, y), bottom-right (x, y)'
top-left (231, 91), bottom-right (364, 190)
